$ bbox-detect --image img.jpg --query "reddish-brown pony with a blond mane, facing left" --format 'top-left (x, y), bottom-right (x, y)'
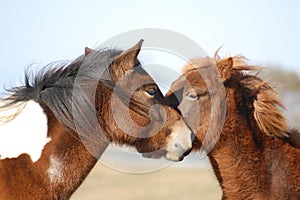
top-left (167, 54), bottom-right (300, 200)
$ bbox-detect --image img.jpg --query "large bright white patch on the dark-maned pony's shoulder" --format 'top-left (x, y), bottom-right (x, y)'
top-left (0, 101), bottom-right (50, 162)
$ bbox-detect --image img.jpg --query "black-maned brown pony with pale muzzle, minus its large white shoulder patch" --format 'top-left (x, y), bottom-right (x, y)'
top-left (0, 40), bottom-right (192, 199)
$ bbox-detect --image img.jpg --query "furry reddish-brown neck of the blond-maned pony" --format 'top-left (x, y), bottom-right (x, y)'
top-left (208, 85), bottom-right (267, 199)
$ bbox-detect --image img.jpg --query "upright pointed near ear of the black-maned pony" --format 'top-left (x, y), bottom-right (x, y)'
top-left (111, 39), bottom-right (144, 79)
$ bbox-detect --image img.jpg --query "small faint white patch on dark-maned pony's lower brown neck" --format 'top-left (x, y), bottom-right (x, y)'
top-left (47, 155), bottom-right (63, 184)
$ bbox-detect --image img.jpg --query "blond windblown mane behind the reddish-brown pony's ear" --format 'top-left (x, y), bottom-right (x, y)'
top-left (227, 56), bottom-right (289, 137)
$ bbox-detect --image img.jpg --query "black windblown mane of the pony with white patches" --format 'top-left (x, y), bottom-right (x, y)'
top-left (0, 50), bottom-right (122, 129)
